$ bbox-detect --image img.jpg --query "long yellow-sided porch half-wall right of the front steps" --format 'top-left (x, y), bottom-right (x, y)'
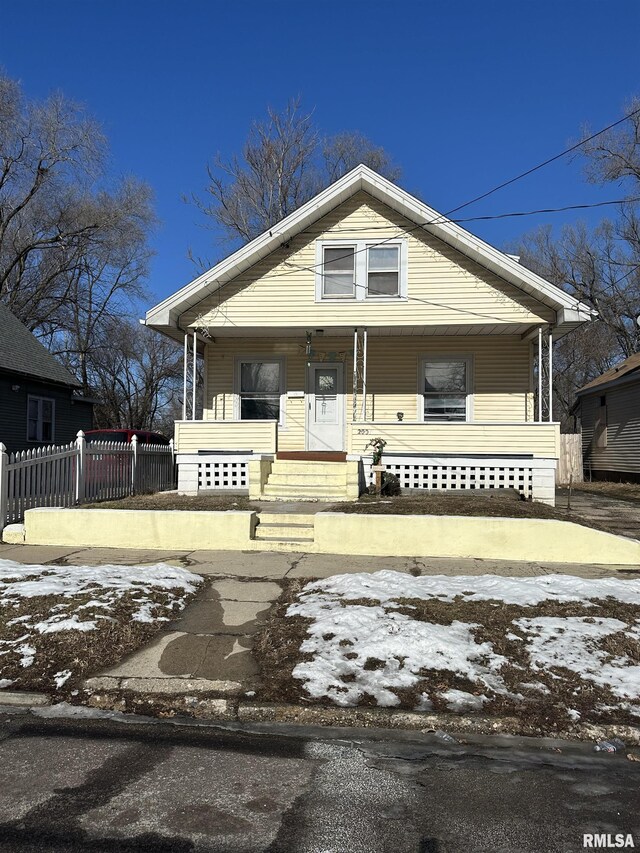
top-left (347, 422), bottom-right (560, 458)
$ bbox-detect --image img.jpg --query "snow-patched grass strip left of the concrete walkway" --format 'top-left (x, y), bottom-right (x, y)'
top-left (0, 560), bottom-right (202, 692)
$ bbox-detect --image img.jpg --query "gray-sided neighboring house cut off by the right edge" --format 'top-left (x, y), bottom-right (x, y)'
top-left (574, 353), bottom-right (640, 482)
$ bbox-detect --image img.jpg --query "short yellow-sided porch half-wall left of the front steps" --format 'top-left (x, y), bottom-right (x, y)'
top-left (174, 421), bottom-right (277, 453)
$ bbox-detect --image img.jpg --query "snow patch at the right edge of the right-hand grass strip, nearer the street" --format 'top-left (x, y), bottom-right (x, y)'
top-left (515, 616), bottom-right (640, 699)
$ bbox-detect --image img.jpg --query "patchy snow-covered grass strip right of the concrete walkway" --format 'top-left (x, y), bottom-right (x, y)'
top-left (262, 571), bottom-right (640, 727)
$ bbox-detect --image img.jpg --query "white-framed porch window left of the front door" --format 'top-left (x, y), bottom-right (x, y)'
top-left (236, 358), bottom-right (284, 423)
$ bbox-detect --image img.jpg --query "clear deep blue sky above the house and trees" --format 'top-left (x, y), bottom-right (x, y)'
top-left (0, 0), bottom-right (640, 298)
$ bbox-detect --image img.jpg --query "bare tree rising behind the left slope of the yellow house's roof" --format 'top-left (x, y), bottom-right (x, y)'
top-left (190, 98), bottom-right (400, 251)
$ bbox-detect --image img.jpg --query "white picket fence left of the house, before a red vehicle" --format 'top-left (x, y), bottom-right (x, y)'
top-left (0, 431), bottom-right (175, 530)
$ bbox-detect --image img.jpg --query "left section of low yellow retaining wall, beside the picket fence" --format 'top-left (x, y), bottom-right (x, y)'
top-left (24, 508), bottom-right (256, 551)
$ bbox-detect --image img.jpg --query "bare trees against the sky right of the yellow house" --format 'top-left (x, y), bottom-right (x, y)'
top-left (512, 99), bottom-right (640, 426)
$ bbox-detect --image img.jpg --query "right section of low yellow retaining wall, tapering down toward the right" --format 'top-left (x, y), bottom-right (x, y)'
top-left (314, 512), bottom-right (640, 566)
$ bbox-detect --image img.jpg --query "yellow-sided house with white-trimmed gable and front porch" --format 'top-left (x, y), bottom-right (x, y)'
top-left (146, 166), bottom-right (594, 503)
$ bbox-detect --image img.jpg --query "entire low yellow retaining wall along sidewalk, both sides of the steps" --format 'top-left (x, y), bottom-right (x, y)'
top-left (16, 508), bottom-right (640, 566)
